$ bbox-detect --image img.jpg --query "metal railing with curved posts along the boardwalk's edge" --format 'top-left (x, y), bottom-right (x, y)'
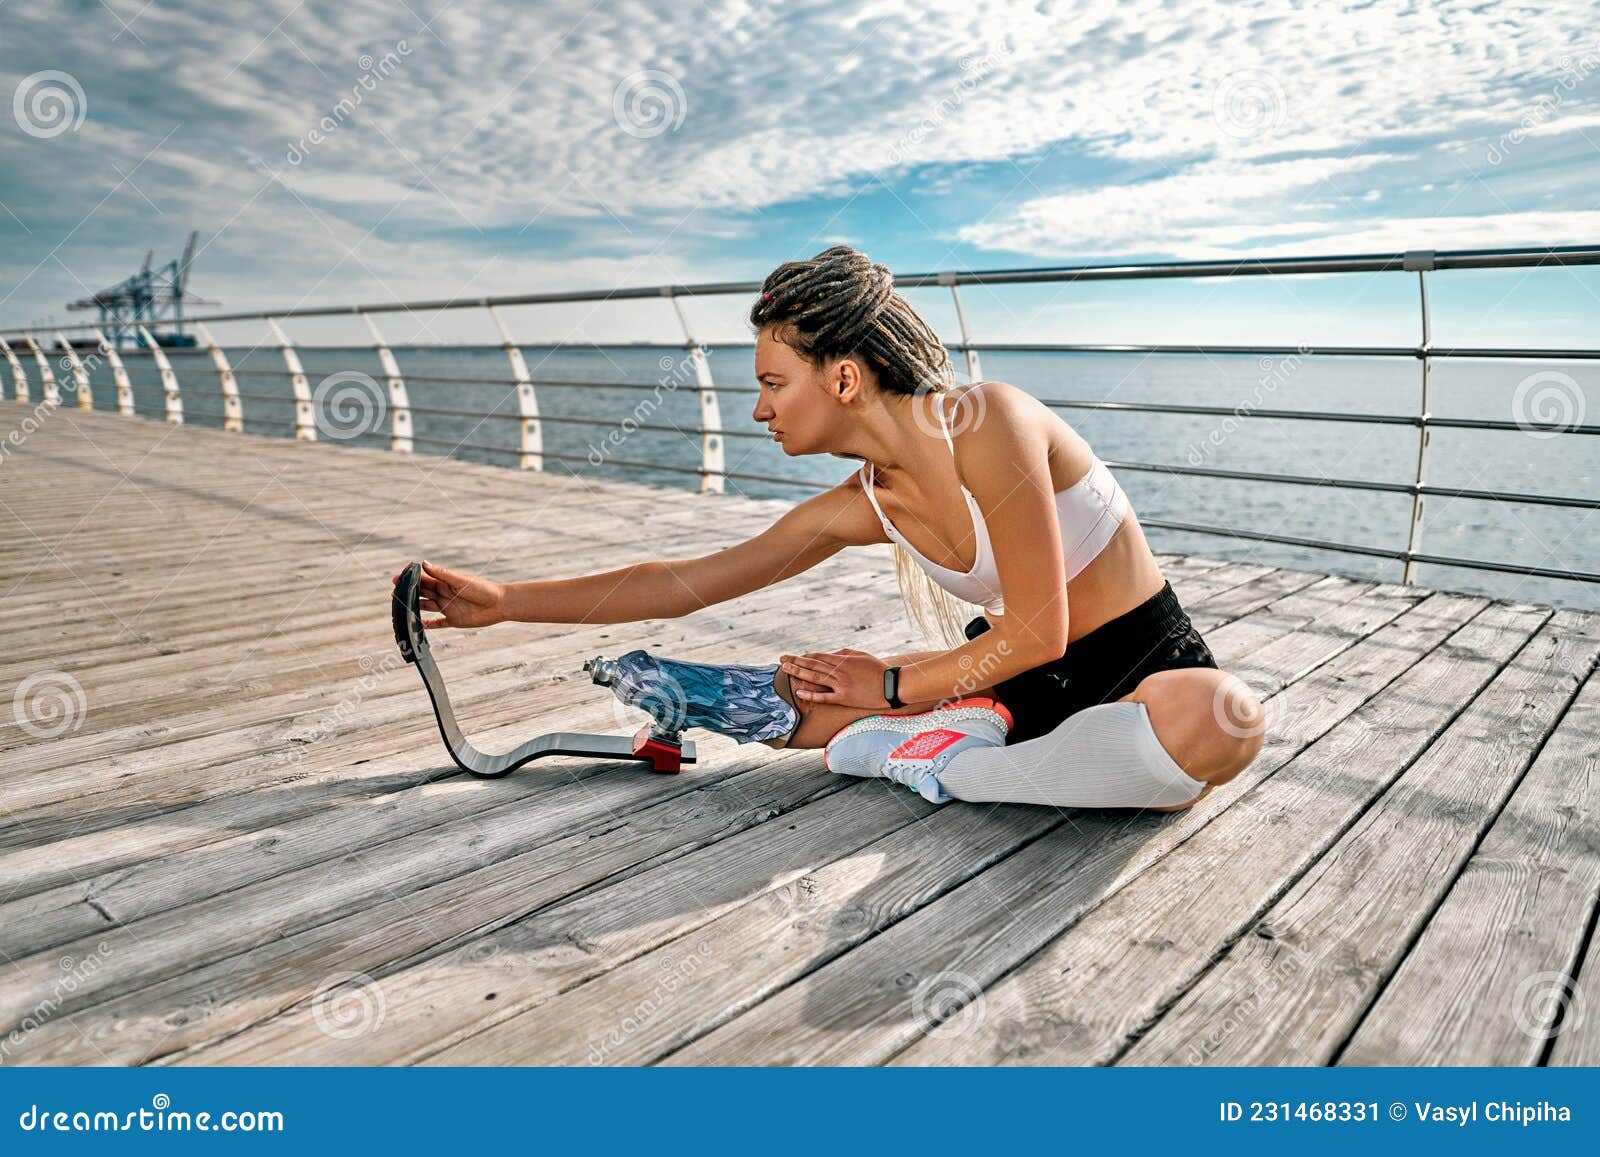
top-left (0, 246), bottom-right (1600, 584)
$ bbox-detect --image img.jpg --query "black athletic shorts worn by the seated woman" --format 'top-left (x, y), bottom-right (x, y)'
top-left (966, 583), bottom-right (1216, 744)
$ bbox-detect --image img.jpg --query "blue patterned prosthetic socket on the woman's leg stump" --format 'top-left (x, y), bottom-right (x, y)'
top-left (595, 650), bottom-right (800, 743)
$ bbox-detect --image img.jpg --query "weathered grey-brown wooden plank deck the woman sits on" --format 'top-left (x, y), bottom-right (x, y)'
top-left (0, 402), bottom-right (1600, 1066)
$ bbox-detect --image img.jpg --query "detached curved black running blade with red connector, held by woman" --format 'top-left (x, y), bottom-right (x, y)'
top-left (389, 563), bottom-right (694, 779)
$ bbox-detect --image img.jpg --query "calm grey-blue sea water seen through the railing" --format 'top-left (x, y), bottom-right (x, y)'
top-left (103, 346), bottom-right (1600, 608)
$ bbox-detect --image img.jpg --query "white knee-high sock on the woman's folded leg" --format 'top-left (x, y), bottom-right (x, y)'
top-left (939, 703), bottom-right (1205, 808)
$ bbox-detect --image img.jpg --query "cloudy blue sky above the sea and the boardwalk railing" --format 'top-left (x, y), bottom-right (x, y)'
top-left (0, 0), bottom-right (1600, 346)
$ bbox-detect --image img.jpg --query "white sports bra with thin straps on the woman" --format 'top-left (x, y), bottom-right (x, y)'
top-left (861, 384), bottom-right (1128, 615)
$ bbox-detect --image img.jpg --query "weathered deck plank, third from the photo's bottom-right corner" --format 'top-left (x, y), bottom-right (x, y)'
top-left (1122, 610), bottom-right (1600, 1064)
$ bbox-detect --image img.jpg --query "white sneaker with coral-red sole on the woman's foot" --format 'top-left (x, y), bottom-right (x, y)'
top-left (822, 696), bottom-right (1011, 803)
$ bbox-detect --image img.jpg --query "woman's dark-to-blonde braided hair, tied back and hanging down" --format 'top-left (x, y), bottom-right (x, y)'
top-left (750, 245), bottom-right (973, 647)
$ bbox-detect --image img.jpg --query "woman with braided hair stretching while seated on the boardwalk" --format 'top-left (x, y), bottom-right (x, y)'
top-left (387, 246), bottom-right (1264, 811)
